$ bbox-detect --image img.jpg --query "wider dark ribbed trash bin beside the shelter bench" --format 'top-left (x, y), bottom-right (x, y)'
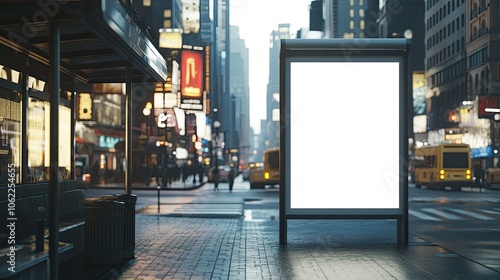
top-left (84, 197), bottom-right (125, 264)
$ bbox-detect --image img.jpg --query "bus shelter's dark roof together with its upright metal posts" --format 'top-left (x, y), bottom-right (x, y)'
top-left (0, 0), bottom-right (167, 279)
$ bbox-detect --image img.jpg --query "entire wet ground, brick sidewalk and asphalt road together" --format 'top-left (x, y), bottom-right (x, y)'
top-left (77, 177), bottom-right (500, 279)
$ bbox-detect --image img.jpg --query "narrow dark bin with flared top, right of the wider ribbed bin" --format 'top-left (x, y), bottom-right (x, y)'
top-left (115, 194), bottom-right (137, 259)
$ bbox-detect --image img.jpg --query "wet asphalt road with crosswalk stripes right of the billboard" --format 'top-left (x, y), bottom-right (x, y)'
top-left (409, 185), bottom-right (500, 271)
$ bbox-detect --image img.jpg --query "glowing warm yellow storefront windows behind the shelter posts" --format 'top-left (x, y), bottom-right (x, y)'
top-left (0, 65), bottom-right (72, 185)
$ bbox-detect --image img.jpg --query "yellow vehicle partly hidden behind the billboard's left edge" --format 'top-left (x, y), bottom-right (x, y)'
top-left (250, 148), bottom-right (280, 189)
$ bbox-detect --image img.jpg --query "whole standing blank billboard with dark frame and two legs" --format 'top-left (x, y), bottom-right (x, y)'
top-left (279, 38), bottom-right (410, 245)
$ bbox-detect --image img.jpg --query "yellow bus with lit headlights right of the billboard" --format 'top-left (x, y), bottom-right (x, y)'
top-left (414, 144), bottom-right (472, 189)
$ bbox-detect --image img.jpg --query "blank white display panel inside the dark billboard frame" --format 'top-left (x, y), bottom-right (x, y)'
top-left (289, 59), bottom-right (402, 212)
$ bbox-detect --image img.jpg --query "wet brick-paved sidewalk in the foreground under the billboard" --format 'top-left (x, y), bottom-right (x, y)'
top-left (61, 210), bottom-right (500, 280)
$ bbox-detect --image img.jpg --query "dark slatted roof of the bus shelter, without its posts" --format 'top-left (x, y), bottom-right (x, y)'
top-left (0, 0), bottom-right (167, 83)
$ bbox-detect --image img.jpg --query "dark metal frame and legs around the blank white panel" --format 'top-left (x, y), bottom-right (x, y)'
top-left (279, 38), bottom-right (410, 245)
